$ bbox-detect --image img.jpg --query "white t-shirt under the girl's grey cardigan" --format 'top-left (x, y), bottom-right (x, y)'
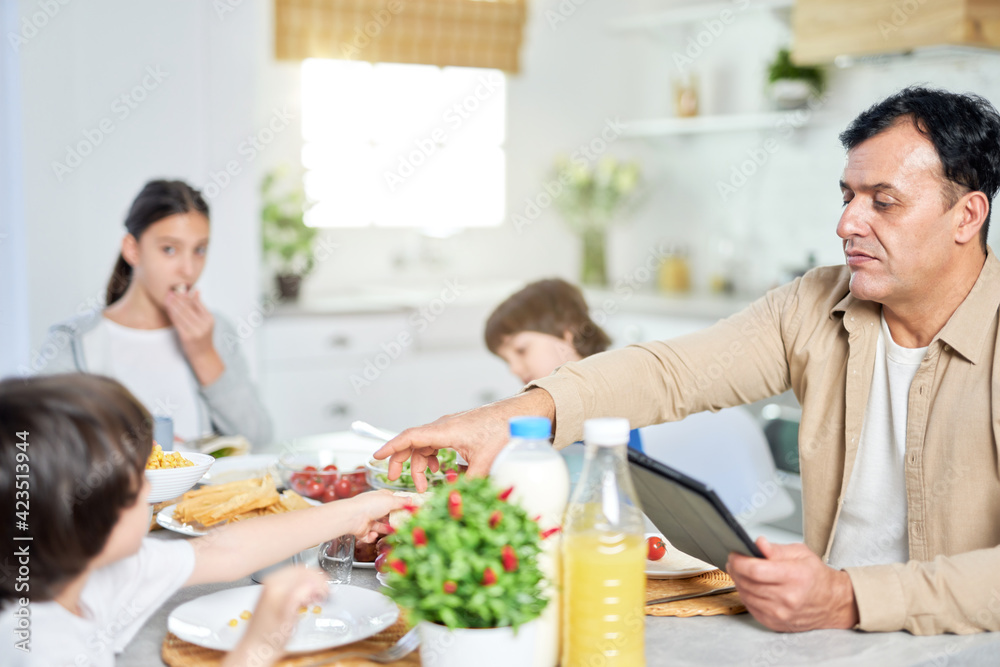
top-left (83, 317), bottom-right (209, 449)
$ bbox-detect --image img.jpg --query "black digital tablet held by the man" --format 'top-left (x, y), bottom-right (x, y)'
top-left (628, 449), bottom-right (764, 570)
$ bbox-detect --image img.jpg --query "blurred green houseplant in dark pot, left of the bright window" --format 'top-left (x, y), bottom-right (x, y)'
top-left (260, 168), bottom-right (316, 300)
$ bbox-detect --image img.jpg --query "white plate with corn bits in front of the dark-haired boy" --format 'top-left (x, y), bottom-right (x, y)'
top-left (167, 584), bottom-right (399, 653)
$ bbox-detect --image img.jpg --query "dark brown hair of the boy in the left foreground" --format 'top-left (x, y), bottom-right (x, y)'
top-left (0, 374), bottom-right (153, 607)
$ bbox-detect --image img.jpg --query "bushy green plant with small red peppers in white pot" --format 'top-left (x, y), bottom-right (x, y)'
top-left (383, 475), bottom-right (548, 667)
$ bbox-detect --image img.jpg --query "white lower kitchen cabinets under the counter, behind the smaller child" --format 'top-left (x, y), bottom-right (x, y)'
top-left (258, 294), bottom-right (740, 441)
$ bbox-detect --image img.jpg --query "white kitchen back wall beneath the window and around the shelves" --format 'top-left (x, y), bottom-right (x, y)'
top-left (280, 0), bottom-right (1000, 295)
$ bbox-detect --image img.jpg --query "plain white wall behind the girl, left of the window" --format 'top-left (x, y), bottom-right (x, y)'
top-left (14, 0), bottom-right (271, 376)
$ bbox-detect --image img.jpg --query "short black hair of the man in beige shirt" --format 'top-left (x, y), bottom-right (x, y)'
top-left (840, 86), bottom-right (1000, 252)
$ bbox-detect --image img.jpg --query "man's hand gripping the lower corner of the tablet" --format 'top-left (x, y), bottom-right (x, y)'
top-left (726, 537), bottom-right (858, 632)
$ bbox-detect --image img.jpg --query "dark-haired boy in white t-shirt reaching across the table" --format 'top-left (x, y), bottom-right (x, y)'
top-left (0, 375), bottom-right (405, 667)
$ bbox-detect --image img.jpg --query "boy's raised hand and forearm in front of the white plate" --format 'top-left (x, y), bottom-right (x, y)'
top-left (222, 567), bottom-right (328, 667)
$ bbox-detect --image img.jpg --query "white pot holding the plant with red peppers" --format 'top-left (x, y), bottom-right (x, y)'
top-left (419, 620), bottom-right (538, 667)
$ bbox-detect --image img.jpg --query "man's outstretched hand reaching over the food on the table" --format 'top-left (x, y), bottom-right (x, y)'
top-left (374, 388), bottom-right (556, 492)
